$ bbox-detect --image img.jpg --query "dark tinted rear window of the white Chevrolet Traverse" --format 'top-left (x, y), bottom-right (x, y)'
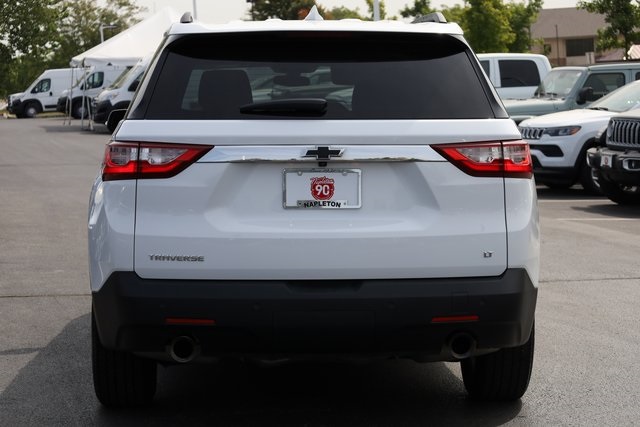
top-left (136, 32), bottom-right (494, 120)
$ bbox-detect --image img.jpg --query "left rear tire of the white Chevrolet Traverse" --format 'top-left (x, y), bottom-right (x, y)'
top-left (91, 315), bottom-right (157, 407)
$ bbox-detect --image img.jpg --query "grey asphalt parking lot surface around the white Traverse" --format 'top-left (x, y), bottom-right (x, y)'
top-left (0, 118), bottom-right (640, 426)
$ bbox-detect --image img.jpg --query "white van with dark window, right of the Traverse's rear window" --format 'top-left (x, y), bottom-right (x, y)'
top-left (478, 53), bottom-right (551, 99)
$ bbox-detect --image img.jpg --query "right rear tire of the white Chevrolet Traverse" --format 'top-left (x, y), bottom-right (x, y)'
top-left (460, 328), bottom-right (535, 401)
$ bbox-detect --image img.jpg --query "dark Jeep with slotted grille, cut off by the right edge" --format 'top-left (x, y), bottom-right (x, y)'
top-left (587, 109), bottom-right (640, 205)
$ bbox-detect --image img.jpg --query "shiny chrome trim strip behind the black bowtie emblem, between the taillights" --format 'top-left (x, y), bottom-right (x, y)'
top-left (198, 144), bottom-right (445, 163)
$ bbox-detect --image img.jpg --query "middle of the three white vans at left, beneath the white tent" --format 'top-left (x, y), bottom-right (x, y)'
top-left (57, 64), bottom-right (134, 119)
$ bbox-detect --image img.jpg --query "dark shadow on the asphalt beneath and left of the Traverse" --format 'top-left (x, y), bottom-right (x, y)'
top-left (0, 314), bottom-right (522, 426)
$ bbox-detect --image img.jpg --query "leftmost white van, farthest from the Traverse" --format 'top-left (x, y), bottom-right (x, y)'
top-left (8, 68), bottom-right (73, 118)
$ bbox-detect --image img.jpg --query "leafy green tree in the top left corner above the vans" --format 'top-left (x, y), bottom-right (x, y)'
top-left (0, 0), bottom-right (60, 98)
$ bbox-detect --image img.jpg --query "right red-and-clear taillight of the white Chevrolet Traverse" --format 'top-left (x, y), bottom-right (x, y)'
top-left (431, 140), bottom-right (533, 178)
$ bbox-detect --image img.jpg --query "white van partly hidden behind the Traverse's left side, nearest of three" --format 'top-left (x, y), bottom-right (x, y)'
top-left (92, 58), bottom-right (151, 132)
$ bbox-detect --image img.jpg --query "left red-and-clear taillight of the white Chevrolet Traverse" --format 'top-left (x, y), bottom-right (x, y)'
top-left (102, 142), bottom-right (213, 181)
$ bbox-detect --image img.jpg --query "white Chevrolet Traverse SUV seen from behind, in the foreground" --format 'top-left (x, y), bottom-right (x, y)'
top-left (89, 12), bottom-right (540, 406)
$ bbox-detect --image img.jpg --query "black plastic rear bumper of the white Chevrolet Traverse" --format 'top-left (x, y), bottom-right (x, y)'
top-left (93, 269), bottom-right (537, 361)
